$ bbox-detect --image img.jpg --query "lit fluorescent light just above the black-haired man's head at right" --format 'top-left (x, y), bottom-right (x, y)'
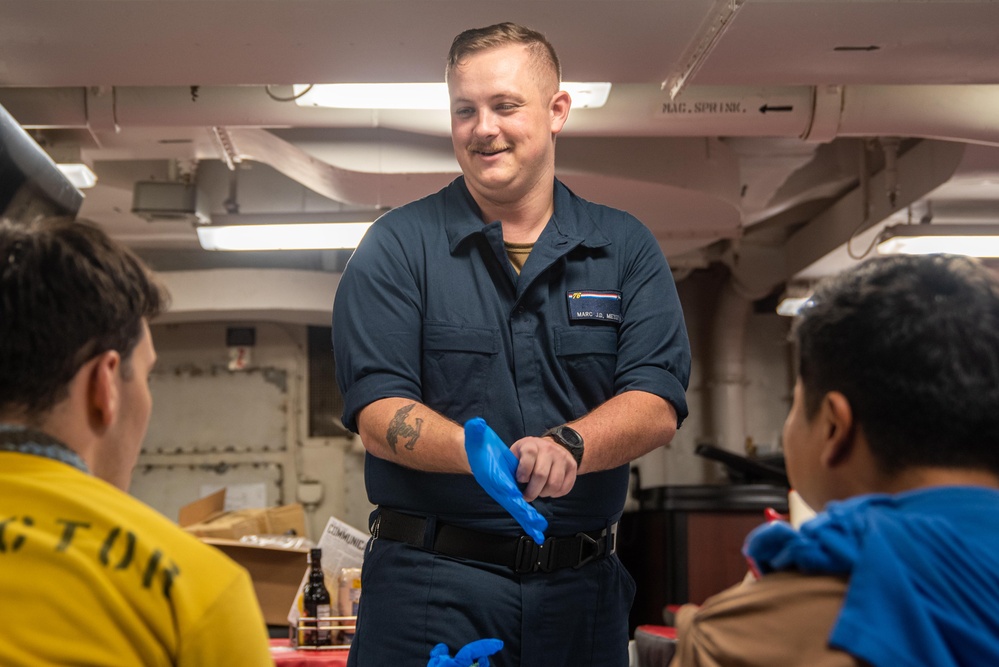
top-left (878, 223), bottom-right (999, 257)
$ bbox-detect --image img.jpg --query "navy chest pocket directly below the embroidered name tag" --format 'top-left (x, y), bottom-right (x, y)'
top-left (555, 327), bottom-right (617, 412)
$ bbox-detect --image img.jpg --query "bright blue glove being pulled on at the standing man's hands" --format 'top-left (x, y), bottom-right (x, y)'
top-left (465, 417), bottom-right (548, 544)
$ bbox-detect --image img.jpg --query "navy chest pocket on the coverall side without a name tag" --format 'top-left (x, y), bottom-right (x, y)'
top-left (422, 322), bottom-right (500, 423)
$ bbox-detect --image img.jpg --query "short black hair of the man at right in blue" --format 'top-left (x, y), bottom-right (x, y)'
top-left (793, 255), bottom-right (999, 474)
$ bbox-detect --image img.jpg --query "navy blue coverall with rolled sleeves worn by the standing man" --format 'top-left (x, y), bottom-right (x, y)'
top-left (333, 177), bottom-right (690, 667)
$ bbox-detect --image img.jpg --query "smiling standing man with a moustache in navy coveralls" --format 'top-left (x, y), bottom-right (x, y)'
top-left (333, 23), bottom-right (690, 667)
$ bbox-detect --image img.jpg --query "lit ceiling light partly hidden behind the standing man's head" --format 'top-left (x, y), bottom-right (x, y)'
top-left (292, 81), bottom-right (611, 110)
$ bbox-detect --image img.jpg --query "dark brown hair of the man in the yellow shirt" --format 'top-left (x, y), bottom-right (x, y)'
top-left (0, 218), bottom-right (169, 419)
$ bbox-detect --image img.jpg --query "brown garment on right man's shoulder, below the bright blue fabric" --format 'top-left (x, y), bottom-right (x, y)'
top-left (670, 572), bottom-right (865, 667)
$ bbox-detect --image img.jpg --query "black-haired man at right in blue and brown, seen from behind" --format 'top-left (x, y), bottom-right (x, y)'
top-left (674, 255), bottom-right (999, 667)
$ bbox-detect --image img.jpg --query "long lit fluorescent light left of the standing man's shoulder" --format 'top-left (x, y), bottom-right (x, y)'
top-left (197, 222), bottom-right (371, 251)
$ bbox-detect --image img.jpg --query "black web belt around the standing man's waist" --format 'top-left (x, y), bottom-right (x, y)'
top-left (371, 508), bottom-right (617, 574)
